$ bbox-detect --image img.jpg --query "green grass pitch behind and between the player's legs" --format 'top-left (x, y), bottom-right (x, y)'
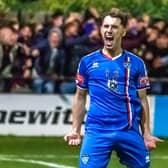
top-left (0, 136), bottom-right (168, 168)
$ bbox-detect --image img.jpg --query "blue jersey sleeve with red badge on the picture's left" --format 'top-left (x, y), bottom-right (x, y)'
top-left (76, 59), bottom-right (88, 89)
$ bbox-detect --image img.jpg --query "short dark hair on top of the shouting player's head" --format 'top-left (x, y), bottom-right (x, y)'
top-left (101, 8), bottom-right (129, 27)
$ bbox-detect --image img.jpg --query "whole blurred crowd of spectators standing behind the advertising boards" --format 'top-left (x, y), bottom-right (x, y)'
top-left (0, 8), bottom-right (168, 94)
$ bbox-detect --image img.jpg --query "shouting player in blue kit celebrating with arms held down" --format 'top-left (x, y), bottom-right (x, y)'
top-left (65, 9), bottom-right (161, 168)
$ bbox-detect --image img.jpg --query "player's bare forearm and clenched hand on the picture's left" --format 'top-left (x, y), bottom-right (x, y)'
top-left (64, 87), bottom-right (87, 145)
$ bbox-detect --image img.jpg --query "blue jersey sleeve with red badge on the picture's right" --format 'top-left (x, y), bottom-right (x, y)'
top-left (136, 61), bottom-right (150, 89)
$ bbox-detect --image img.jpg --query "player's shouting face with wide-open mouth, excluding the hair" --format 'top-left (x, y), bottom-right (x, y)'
top-left (101, 15), bottom-right (126, 50)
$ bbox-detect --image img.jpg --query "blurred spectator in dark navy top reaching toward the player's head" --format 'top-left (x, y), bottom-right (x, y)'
top-left (61, 20), bottom-right (101, 93)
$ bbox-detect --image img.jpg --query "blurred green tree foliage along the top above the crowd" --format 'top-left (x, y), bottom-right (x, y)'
top-left (0, 0), bottom-right (168, 19)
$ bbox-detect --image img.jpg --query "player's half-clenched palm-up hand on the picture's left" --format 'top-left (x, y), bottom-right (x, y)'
top-left (64, 132), bottom-right (82, 146)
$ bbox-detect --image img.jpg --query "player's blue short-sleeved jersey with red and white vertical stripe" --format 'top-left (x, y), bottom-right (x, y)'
top-left (76, 50), bottom-right (149, 130)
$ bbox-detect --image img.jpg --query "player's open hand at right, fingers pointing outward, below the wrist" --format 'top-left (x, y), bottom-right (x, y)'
top-left (144, 135), bottom-right (163, 150)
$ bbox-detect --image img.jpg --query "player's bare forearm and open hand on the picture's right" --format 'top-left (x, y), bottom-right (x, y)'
top-left (138, 89), bottom-right (163, 150)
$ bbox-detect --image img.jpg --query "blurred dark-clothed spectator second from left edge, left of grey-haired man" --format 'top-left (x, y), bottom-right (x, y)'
top-left (9, 24), bottom-right (33, 92)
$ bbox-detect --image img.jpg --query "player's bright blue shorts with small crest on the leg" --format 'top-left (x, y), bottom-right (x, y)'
top-left (80, 129), bottom-right (150, 168)
